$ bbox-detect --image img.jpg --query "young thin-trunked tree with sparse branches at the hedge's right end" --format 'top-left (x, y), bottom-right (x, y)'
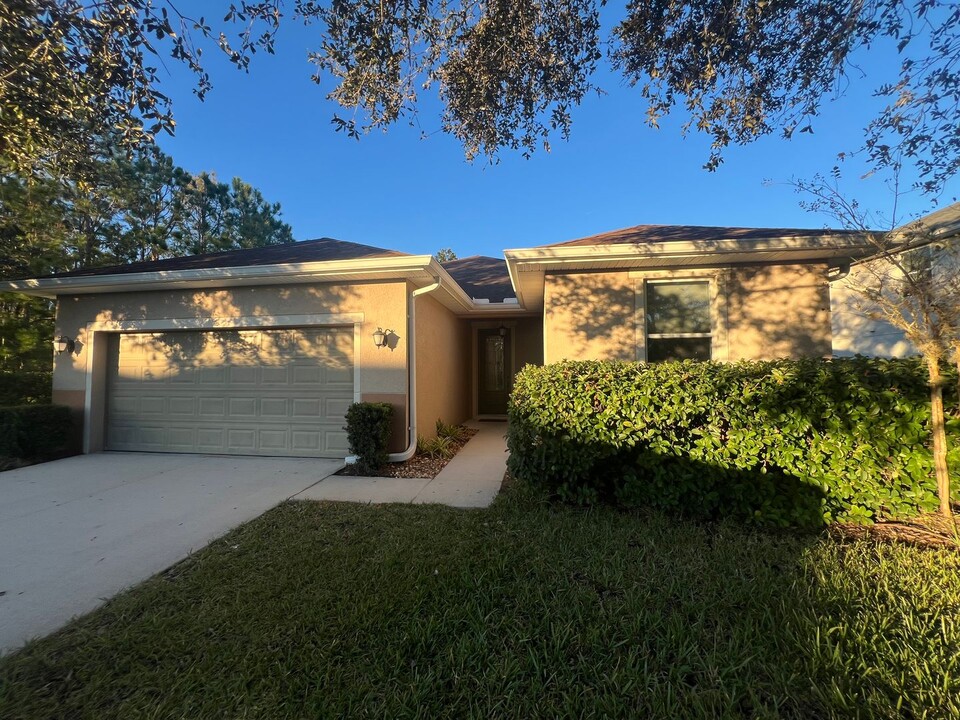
top-left (793, 177), bottom-right (960, 518)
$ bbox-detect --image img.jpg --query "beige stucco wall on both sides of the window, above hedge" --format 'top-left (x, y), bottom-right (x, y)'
top-left (544, 264), bottom-right (831, 363)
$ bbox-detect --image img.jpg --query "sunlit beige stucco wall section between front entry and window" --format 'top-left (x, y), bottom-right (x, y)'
top-left (543, 272), bottom-right (636, 363)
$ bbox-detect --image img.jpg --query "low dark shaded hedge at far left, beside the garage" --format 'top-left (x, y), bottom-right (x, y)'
top-left (0, 405), bottom-right (72, 459)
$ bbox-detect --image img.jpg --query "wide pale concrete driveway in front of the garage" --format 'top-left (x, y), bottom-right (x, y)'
top-left (0, 453), bottom-right (343, 654)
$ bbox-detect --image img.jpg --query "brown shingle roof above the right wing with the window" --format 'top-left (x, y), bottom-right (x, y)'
top-left (539, 225), bottom-right (857, 248)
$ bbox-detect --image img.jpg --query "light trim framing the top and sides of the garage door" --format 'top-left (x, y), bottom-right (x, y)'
top-left (83, 313), bottom-right (364, 453)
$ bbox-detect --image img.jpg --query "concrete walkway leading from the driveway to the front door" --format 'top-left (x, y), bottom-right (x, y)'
top-left (295, 422), bottom-right (507, 508)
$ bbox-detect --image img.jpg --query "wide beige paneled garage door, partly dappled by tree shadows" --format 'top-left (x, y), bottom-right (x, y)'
top-left (106, 328), bottom-right (354, 457)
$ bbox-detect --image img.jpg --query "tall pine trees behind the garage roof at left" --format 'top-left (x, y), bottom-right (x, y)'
top-left (0, 139), bottom-right (293, 371)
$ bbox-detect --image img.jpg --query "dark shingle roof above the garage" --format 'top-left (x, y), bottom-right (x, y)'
top-left (50, 238), bottom-right (407, 277)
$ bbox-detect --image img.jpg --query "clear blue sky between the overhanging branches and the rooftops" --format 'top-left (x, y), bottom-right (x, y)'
top-left (159, 2), bottom-right (957, 257)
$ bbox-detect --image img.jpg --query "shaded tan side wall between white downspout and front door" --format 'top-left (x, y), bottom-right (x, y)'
top-left (415, 295), bottom-right (471, 438)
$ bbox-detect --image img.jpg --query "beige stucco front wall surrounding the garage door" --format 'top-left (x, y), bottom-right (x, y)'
top-left (53, 282), bottom-right (407, 450)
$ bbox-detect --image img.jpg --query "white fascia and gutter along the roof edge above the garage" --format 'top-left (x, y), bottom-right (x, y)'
top-left (0, 255), bottom-right (439, 298)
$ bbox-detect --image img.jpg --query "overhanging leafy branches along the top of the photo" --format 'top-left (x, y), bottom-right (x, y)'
top-left (0, 0), bottom-right (960, 192)
